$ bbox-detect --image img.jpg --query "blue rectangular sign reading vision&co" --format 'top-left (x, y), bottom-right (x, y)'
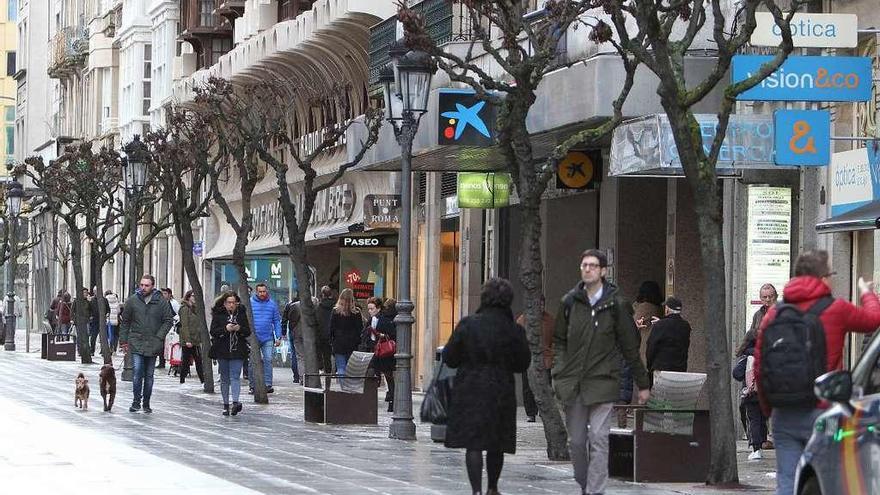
top-left (732, 55), bottom-right (873, 101)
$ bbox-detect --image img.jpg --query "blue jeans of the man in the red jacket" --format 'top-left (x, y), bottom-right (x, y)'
top-left (770, 408), bottom-right (821, 495)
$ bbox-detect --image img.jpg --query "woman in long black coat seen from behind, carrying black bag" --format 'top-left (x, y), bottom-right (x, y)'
top-left (443, 278), bottom-right (530, 495)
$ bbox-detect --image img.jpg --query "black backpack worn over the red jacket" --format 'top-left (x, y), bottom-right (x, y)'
top-left (759, 296), bottom-right (834, 408)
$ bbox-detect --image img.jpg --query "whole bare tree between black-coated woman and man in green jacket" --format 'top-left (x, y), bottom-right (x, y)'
top-left (398, 0), bottom-right (638, 460)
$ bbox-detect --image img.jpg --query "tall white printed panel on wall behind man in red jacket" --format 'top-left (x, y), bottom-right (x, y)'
top-left (743, 186), bottom-right (791, 333)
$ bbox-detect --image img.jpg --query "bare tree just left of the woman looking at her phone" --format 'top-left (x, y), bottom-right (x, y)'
top-left (146, 107), bottom-right (223, 393)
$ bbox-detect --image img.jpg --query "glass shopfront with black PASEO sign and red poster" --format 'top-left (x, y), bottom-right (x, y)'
top-left (339, 236), bottom-right (397, 302)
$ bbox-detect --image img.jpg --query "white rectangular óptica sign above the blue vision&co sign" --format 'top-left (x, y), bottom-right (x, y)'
top-left (750, 12), bottom-right (859, 48)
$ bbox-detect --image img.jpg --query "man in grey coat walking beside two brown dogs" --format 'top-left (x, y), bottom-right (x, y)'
top-left (119, 275), bottom-right (174, 413)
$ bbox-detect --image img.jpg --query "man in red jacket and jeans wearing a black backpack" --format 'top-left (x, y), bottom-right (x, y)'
top-left (754, 250), bottom-right (880, 495)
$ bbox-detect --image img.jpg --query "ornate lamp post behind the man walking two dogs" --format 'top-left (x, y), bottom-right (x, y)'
top-left (122, 134), bottom-right (150, 382)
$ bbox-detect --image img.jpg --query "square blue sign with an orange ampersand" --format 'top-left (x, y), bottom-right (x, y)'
top-left (773, 110), bottom-right (831, 166)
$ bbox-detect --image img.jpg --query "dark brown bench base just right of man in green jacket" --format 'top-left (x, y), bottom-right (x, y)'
top-left (608, 372), bottom-right (711, 483)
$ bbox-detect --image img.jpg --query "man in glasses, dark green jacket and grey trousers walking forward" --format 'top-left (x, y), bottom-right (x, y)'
top-left (552, 249), bottom-right (650, 494)
